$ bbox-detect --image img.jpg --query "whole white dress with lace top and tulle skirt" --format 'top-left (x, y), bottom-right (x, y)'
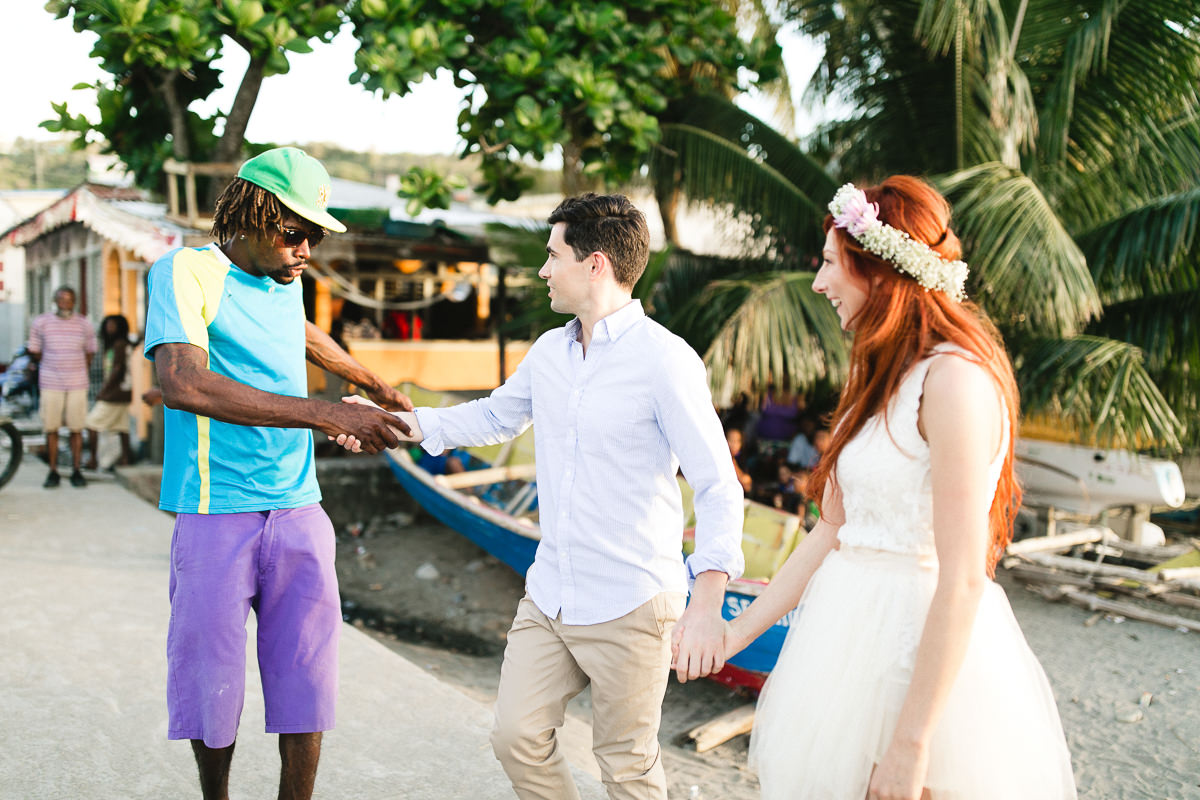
top-left (750, 345), bottom-right (1075, 800)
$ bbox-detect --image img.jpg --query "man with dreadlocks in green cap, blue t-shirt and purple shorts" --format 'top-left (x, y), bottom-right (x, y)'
top-left (145, 148), bottom-right (412, 800)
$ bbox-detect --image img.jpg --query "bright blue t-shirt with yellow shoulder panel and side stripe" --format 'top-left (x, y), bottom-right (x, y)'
top-left (145, 245), bottom-right (320, 513)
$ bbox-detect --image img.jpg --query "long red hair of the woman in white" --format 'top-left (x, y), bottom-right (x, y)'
top-left (811, 175), bottom-right (1021, 576)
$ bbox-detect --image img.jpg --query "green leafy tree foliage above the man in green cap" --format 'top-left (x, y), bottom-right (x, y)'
top-left (42, 0), bottom-right (342, 186)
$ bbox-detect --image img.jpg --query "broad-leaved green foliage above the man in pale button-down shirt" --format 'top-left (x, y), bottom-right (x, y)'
top-left (347, 0), bottom-right (779, 203)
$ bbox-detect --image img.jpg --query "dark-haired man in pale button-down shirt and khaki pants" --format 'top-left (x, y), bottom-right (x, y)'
top-left (349, 194), bottom-right (743, 800)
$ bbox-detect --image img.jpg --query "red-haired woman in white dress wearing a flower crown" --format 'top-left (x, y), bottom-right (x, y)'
top-left (691, 176), bottom-right (1075, 800)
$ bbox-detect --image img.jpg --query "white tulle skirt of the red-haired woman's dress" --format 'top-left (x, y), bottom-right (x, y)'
top-left (750, 546), bottom-right (1075, 800)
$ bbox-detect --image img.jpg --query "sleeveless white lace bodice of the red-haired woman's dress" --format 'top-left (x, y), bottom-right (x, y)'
top-left (838, 344), bottom-right (1008, 557)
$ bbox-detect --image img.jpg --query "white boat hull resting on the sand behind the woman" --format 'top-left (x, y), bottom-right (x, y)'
top-left (1016, 438), bottom-right (1186, 516)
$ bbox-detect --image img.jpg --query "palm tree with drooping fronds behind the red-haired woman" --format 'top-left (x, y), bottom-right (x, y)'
top-left (656, 0), bottom-right (1200, 450)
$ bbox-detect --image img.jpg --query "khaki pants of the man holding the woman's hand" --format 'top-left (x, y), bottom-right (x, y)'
top-left (492, 593), bottom-right (684, 800)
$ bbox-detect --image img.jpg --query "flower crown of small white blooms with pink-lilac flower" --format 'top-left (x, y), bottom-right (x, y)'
top-left (829, 184), bottom-right (967, 301)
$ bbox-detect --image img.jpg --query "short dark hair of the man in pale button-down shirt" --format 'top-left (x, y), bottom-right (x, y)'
top-left (550, 192), bottom-right (650, 288)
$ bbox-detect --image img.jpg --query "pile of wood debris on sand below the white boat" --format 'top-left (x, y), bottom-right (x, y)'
top-left (1001, 528), bottom-right (1200, 631)
